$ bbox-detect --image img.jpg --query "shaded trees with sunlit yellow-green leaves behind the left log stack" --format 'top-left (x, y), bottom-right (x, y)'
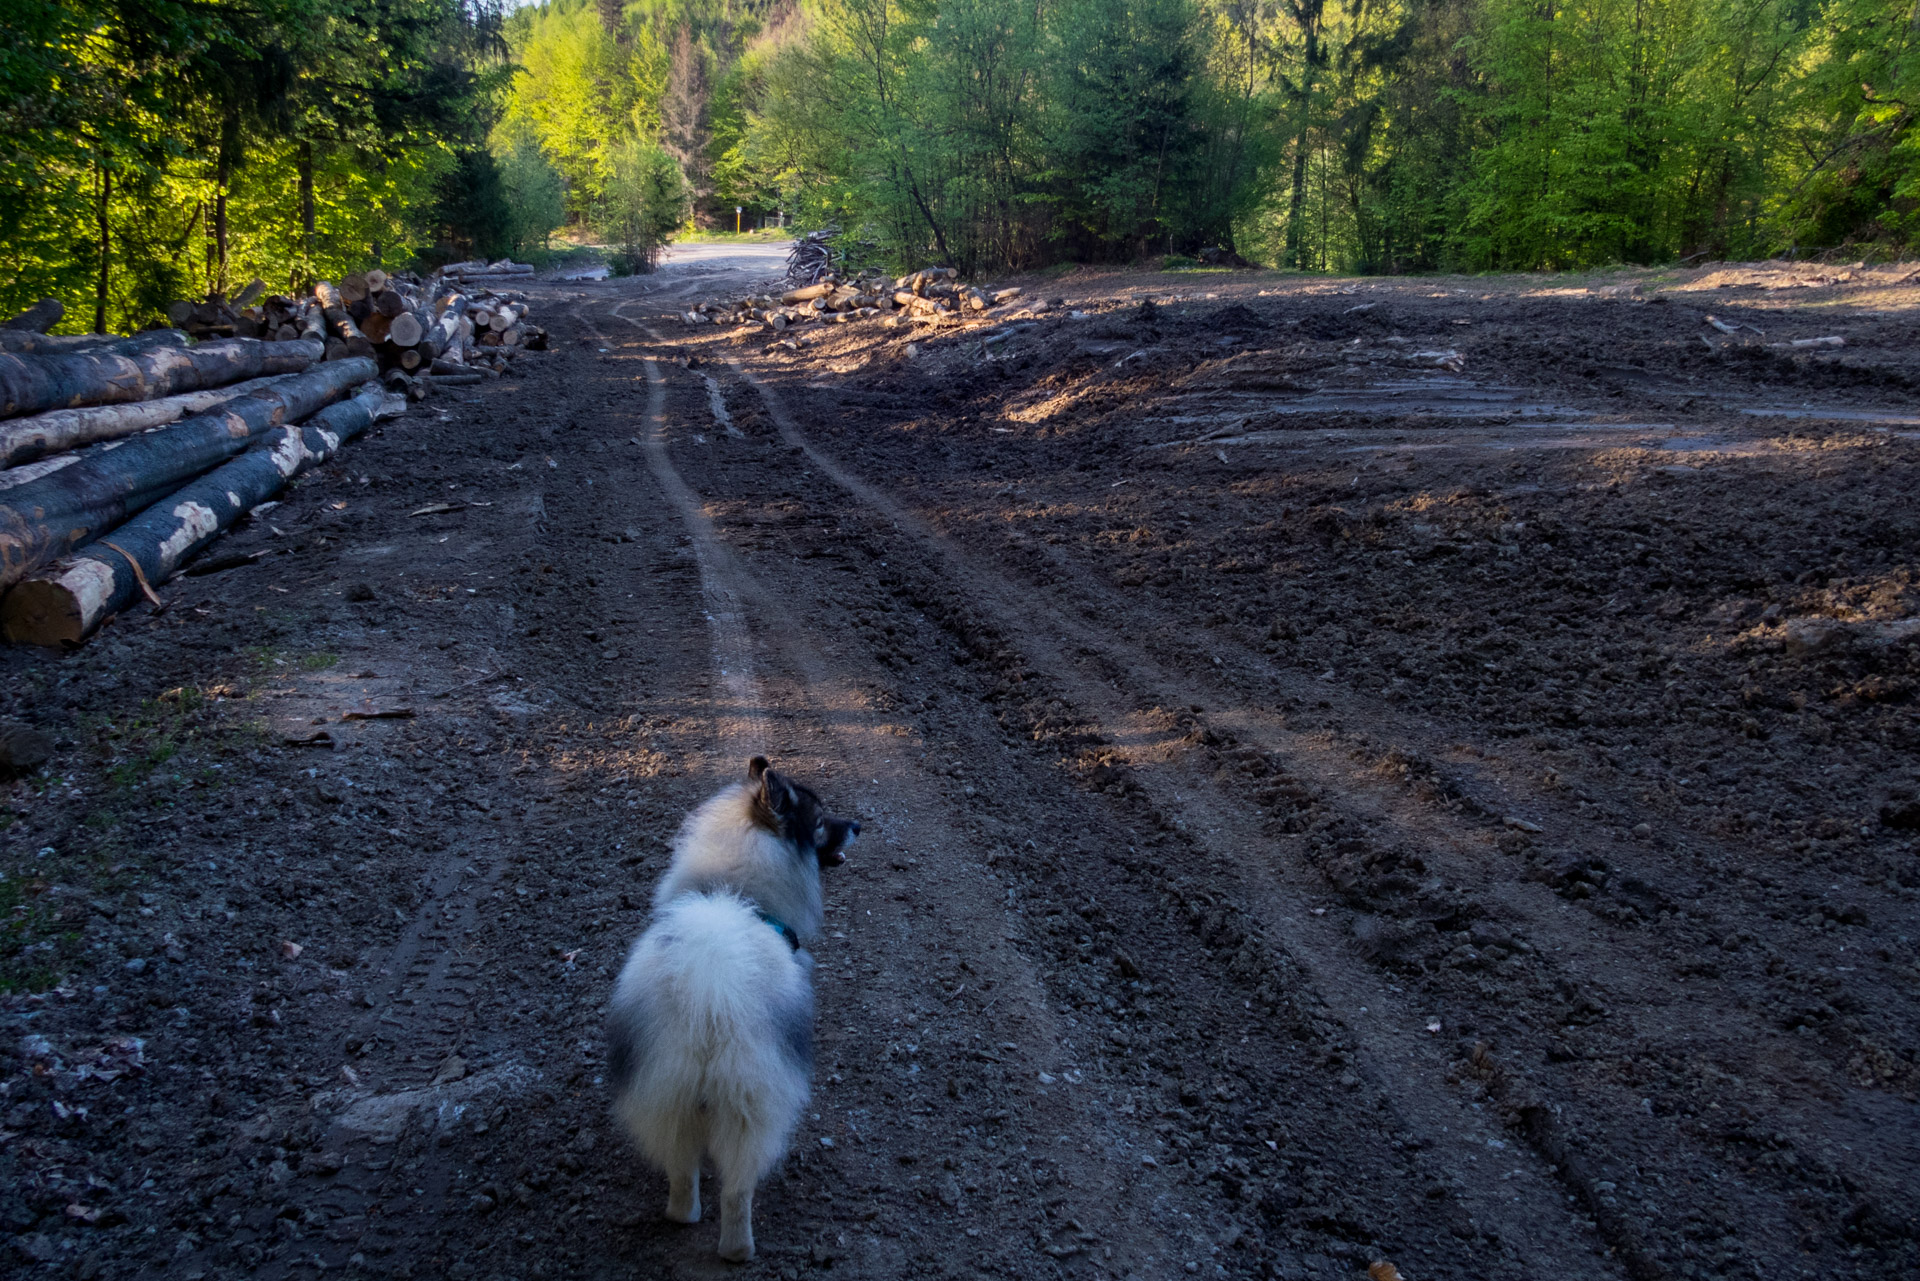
top-left (0, 0), bottom-right (505, 330)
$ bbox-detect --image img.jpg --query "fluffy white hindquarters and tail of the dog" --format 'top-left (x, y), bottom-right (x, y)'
top-left (609, 893), bottom-right (814, 1187)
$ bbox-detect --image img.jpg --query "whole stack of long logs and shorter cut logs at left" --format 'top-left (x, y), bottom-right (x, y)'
top-left (0, 263), bottom-right (547, 645)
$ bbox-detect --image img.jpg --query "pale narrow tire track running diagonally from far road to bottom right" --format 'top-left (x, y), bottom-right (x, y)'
top-left (706, 353), bottom-right (1657, 1277)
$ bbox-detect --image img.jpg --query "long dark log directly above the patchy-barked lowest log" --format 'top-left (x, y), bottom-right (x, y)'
top-left (0, 359), bottom-right (378, 590)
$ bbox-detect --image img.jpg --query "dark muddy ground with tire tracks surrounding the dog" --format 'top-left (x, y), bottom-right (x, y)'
top-left (0, 257), bottom-right (1920, 1281)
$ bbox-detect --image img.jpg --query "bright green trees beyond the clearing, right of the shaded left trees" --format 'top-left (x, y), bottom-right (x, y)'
top-left (509, 0), bottom-right (1920, 271)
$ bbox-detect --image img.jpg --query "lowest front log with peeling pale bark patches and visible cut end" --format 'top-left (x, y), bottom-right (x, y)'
top-left (0, 384), bottom-right (403, 645)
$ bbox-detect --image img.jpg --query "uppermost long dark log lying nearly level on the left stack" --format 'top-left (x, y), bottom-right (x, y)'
top-left (0, 338), bottom-right (321, 419)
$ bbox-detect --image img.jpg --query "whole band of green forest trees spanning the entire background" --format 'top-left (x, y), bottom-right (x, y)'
top-left (0, 0), bottom-right (1920, 328)
